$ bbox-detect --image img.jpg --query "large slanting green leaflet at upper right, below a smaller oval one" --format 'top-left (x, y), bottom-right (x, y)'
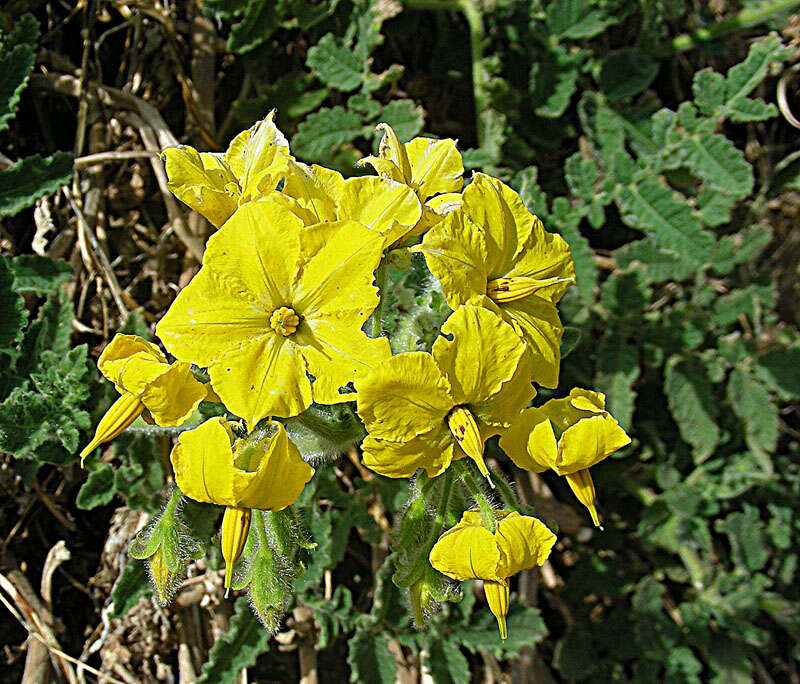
top-left (616, 181), bottom-right (714, 265)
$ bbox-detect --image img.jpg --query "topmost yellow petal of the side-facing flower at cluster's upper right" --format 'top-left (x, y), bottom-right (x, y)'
top-left (461, 173), bottom-right (538, 280)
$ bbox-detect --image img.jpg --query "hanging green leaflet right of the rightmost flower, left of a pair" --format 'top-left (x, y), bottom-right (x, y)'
top-left (664, 356), bottom-right (720, 463)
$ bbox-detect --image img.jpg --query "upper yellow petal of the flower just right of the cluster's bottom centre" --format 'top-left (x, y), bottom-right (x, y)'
top-left (433, 304), bottom-right (534, 426)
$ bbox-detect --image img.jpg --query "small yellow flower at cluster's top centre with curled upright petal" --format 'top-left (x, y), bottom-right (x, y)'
top-left (358, 123), bottom-right (464, 244)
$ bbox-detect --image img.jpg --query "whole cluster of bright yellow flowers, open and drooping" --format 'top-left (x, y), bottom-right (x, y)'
top-left (81, 114), bottom-right (629, 638)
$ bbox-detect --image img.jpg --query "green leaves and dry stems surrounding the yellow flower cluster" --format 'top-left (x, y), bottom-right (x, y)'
top-left (0, 0), bottom-right (800, 683)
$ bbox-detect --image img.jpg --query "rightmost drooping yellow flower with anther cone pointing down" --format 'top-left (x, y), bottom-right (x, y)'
top-left (500, 387), bottom-right (631, 526)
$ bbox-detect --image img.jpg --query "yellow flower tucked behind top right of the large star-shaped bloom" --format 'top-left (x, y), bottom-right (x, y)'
top-left (283, 162), bottom-right (422, 247)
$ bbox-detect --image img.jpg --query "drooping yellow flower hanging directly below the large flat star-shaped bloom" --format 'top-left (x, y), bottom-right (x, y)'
top-left (170, 418), bottom-right (314, 588)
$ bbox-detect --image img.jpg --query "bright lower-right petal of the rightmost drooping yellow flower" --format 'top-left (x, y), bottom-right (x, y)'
top-left (556, 413), bottom-right (631, 475)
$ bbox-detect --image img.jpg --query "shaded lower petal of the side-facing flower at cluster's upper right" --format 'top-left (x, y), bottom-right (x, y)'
top-left (498, 295), bottom-right (564, 388)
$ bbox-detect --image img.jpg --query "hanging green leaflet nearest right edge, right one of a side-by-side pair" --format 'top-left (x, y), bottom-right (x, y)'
top-left (727, 367), bottom-right (780, 472)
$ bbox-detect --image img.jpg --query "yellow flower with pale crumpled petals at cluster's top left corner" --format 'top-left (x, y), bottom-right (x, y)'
top-left (163, 112), bottom-right (291, 228)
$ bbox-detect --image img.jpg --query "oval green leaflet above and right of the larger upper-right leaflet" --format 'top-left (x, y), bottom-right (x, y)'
top-left (680, 133), bottom-right (753, 197)
